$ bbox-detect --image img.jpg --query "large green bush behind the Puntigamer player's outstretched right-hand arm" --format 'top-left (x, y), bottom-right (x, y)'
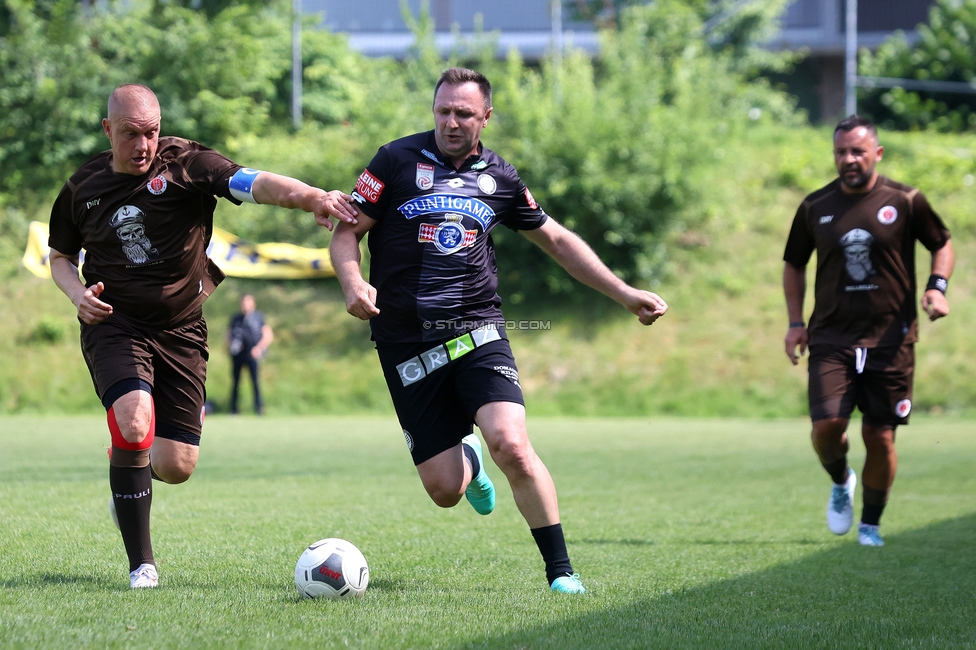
top-left (485, 0), bottom-right (795, 300)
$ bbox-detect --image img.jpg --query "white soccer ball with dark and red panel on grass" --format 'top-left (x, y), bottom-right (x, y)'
top-left (295, 537), bottom-right (369, 598)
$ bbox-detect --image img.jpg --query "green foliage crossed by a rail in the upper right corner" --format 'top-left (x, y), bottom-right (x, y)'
top-left (860, 0), bottom-right (976, 132)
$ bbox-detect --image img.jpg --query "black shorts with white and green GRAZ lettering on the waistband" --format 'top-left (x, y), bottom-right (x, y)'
top-left (376, 332), bottom-right (525, 465)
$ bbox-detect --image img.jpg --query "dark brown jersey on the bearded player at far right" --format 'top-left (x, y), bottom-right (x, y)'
top-left (783, 176), bottom-right (949, 348)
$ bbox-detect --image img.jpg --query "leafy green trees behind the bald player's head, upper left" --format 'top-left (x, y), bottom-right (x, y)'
top-left (0, 0), bottom-right (378, 200)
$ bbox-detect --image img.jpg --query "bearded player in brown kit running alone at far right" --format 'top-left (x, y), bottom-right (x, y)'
top-left (783, 115), bottom-right (955, 546)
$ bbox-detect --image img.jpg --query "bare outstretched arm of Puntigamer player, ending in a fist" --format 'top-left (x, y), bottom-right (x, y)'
top-left (521, 217), bottom-right (668, 325)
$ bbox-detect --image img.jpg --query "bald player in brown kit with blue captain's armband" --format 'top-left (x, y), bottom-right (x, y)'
top-left (48, 84), bottom-right (357, 588)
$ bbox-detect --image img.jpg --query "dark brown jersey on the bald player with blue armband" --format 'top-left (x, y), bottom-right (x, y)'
top-left (48, 138), bottom-right (241, 329)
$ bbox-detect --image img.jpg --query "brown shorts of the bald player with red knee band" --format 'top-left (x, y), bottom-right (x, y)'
top-left (81, 311), bottom-right (210, 444)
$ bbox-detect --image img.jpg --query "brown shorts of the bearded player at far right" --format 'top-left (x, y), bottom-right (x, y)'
top-left (809, 343), bottom-right (915, 427)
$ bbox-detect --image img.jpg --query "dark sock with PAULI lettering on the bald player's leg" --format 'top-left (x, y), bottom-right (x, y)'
top-left (108, 465), bottom-right (156, 571)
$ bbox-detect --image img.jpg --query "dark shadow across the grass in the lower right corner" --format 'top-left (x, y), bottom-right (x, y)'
top-left (465, 514), bottom-right (976, 650)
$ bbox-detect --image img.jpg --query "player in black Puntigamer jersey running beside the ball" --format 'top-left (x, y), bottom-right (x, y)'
top-left (330, 68), bottom-right (667, 593)
